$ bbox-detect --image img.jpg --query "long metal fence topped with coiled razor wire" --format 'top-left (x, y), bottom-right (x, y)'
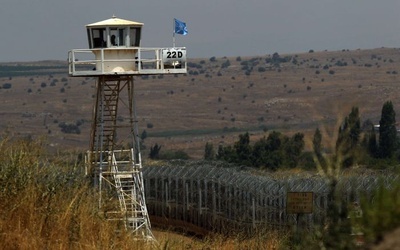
top-left (143, 162), bottom-right (398, 234)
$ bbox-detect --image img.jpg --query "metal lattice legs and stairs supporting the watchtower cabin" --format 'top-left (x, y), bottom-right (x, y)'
top-left (87, 75), bottom-right (154, 239)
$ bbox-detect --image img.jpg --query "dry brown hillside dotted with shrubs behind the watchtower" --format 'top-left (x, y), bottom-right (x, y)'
top-left (0, 48), bottom-right (400, 158)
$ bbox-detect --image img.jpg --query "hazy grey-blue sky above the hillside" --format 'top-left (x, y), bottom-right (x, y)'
top-left (0, 0), bottom-right (400, 62)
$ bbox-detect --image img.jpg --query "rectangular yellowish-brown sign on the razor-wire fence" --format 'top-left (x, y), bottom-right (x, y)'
top-left (286, 192), bottom-right (314, 214)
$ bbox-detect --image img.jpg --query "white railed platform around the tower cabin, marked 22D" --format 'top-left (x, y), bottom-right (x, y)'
top-left (68, 47), bottom-right (187, 76)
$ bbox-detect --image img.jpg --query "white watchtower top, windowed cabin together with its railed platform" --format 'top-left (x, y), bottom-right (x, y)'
top-left (68, 16), bottom-right (187, 76)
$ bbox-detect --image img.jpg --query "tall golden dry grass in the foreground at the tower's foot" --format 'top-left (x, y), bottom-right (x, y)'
top-left (0, 137), bottom-right (285, 250)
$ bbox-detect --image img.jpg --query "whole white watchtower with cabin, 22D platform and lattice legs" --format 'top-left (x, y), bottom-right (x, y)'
top-left (68, 16), bottom-right (187, 239)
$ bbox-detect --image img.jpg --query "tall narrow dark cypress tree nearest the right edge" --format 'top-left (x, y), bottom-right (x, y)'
top-left (379, 101), bottom-right (397, 158)
